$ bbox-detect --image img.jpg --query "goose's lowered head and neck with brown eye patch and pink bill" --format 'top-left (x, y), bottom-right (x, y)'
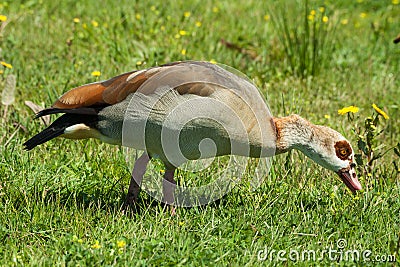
top-left (274, 115), bottom-right (362, 193)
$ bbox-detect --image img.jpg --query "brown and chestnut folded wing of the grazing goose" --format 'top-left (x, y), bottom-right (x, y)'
top-left (52, 61), bottom-right (266, 109)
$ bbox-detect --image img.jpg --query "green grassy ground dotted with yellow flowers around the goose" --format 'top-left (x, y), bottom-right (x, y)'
top-left (0, 0), bottom-right (400, 266)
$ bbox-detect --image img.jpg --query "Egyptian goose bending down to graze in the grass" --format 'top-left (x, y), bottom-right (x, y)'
top-left (24, 61), bottom-right (361, 209)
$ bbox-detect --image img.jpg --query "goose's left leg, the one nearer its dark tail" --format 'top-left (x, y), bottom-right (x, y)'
top-left (125, 153), bottom-right (150, 206)
